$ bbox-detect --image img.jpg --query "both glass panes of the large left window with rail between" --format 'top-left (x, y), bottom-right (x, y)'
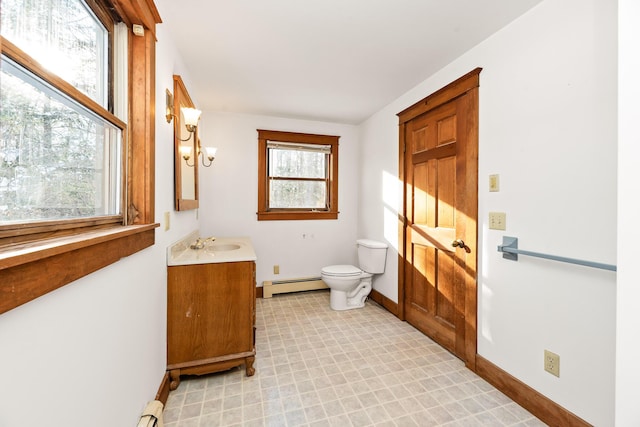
top-left (0, 0), bottom-right (124, 227)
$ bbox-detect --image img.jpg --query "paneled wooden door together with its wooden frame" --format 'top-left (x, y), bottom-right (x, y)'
top-left (400, 71), bottom-right (479, 365)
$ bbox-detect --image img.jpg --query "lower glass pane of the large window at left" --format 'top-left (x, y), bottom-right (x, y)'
top-left (0, 58), bottom-right (122, 224)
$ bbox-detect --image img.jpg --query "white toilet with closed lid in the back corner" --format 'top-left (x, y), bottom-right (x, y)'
top-left (321, 239), bottom-right (388, 310)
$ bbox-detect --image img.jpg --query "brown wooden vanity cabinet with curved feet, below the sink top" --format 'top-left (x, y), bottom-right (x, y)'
top-left (167, 261), bottom-right (256, 390)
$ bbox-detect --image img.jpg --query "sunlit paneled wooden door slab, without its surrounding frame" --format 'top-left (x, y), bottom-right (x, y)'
top-left (405, 96), bottom-right (464, 357)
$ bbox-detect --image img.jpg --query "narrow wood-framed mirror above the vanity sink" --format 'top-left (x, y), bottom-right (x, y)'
top-left (173, 75), bottom-right (198, 211)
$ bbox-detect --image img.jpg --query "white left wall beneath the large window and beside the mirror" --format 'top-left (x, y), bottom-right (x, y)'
top-left (0, 20), bottom-right (198, 427)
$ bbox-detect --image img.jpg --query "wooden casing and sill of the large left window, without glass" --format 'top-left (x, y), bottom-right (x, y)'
top-left (0, 0), bottom-right (162, 314)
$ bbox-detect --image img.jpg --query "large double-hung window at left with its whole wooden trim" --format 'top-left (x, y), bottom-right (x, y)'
top-left (0, 0), bottom-right (161, 313)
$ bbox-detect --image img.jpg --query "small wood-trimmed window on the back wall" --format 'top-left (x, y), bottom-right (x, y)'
top-left (258, 129), bottom-right (340, 220)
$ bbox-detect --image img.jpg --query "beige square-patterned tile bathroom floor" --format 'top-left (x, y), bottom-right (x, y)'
top-left (164, 291), bottom-right (545, 427)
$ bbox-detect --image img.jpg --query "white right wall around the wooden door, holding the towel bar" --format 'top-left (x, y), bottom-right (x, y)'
top-left (359, 0), bottom-right (617, 425)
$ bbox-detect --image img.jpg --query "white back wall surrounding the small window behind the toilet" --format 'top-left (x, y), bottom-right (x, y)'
top-left (200, 111), bottom-right (359, 286)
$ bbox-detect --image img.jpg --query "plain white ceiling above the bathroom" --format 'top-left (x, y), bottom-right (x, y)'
top-left (156, 0), bottom-right (541, 124)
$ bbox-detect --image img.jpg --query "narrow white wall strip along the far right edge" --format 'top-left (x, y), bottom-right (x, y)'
top-left (616, 0), bottom-right (640, 426)
